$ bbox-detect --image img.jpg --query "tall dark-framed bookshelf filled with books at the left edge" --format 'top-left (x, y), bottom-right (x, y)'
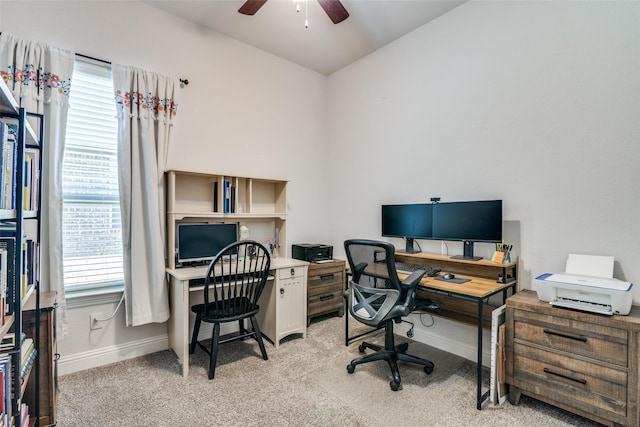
top-left (0, 80), bottom-right (43, 425)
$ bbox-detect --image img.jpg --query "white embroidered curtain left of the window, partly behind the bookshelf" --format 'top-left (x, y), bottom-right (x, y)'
top-left (0, 32), bottom-right (74, 338)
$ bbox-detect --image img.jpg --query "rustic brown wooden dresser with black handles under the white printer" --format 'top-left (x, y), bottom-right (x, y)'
top-left (506, 290), bottom-right (640, 427)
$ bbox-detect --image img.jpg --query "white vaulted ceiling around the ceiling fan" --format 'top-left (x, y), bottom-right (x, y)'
top-left (142, 0), bottom-right (466, 75)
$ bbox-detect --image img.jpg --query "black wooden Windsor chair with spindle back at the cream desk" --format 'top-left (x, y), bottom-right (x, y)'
top-left (189, 240), bottom-right (271, 379)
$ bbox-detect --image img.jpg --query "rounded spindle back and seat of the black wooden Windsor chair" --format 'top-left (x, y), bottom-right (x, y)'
top-left (204, 240), bottom-right (271, 318)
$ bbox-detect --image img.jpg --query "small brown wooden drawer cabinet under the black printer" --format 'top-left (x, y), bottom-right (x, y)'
top-left (307, 259), bottom-right (345, 326)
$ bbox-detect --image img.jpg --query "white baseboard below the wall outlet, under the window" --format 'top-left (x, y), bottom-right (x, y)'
top-left (58, 334), bottom-right (169, 375)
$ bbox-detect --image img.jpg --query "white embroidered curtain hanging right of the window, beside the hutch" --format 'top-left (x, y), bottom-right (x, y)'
top-left (113, 64), bottom-right (178, 326)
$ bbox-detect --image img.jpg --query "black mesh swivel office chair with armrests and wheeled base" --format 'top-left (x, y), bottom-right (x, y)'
top-left (344, 240), bottom-right (433, 391)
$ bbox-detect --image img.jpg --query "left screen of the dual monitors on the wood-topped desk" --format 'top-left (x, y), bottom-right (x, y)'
top-left (382, 203), bottom-right (434, 253)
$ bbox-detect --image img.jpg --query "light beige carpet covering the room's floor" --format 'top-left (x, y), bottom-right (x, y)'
top-left (58, 317), bottom-right (598, 427)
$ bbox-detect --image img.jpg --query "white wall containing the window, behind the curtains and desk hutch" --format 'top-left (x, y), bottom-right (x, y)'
top-left (0, 1), bottom-right (328, 373)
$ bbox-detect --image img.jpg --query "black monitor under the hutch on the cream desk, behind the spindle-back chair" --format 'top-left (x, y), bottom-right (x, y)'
top-left (177, 223), bottom-right (238, 263)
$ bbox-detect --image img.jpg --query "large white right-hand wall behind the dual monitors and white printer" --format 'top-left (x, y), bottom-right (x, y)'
top-left (328, 1), bottom-right (640, 358)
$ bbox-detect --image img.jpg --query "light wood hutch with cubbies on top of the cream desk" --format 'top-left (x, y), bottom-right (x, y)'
top-left (166, 170), bottom-right (287, 269)
